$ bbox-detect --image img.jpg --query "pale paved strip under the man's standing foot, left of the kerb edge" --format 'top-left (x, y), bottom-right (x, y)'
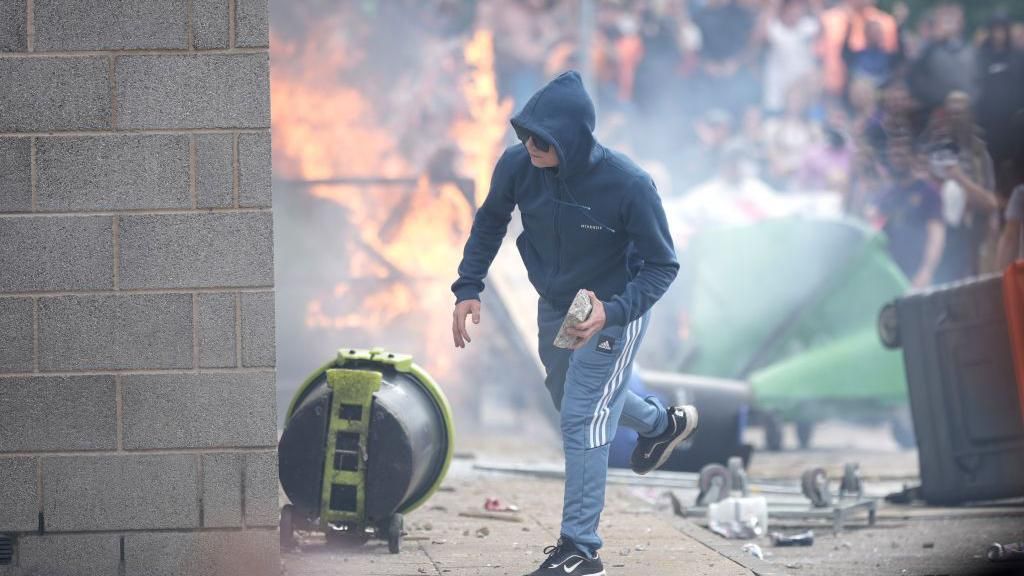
top-left (284, 463), bottom-right (752, 576)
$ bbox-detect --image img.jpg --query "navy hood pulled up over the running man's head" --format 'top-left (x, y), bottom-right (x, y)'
top-left (511, 70), bottom-right (597, 177)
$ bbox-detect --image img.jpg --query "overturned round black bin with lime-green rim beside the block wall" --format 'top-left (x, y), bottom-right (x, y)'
top-left (278, 348), bottom-right (455, 553)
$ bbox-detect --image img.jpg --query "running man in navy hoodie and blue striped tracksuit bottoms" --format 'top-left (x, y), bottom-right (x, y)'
top-left (452, 72), bottom-right (697, 576)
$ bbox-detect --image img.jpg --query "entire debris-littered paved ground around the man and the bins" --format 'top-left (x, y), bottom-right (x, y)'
top-left (283, 416), bottom-right (1024, 576)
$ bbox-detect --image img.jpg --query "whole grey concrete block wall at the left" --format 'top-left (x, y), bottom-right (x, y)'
top-left (0, 0), bottom-right (280, 576)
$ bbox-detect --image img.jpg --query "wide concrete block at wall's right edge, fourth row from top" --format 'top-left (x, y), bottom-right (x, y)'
top-left (120, 212), bottom-right (273, 288)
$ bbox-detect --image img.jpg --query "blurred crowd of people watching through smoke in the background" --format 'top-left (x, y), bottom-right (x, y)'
top-left (480, 0), bottom-right (1024, 287)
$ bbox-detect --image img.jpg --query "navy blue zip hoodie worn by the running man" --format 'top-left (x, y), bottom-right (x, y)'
top-left (452, 72), bottom-right (679, 326)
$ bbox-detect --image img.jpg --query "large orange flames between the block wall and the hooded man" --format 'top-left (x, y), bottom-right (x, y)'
top-left (270, 18), bottom-right (512, 387)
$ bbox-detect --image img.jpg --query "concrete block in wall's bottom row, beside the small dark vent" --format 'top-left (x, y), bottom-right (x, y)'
top-left (9, 534), bottom-right (121, 576)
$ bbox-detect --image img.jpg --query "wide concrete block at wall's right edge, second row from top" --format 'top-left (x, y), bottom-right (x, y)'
top-left (117, 53), bottom-right (270, 128)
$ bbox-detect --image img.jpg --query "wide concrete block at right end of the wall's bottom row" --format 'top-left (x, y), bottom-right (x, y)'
top-left (124, 530), bottom-right (281, 576)
